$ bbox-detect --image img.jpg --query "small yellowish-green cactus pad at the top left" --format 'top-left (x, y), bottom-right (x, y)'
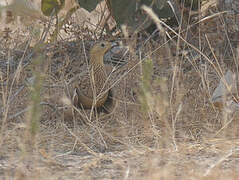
top-left (41, 0), bottom-right (65, 16)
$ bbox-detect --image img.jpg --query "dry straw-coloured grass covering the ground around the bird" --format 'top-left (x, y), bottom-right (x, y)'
top-left (0, 0), bottom-right (239, 180)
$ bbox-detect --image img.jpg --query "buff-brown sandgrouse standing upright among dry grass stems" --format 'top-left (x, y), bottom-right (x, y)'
top-left (67, 41), bottom-right (115, 113)
